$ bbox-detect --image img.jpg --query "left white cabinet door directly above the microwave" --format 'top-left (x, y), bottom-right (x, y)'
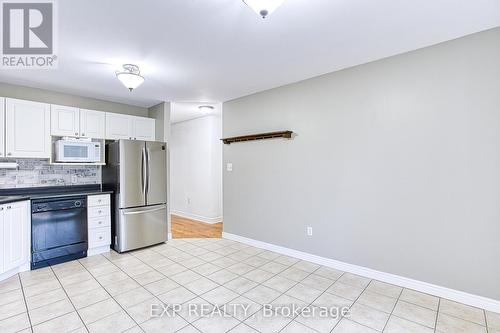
top-left (50, 105), bottom-right (80, 136)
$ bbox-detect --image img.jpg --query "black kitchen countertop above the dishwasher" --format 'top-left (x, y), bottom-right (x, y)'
top-left (0, 185), bottom-right (113, 204)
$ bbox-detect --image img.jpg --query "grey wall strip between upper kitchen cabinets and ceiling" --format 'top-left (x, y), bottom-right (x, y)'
top-left (0, 82), bottom-right (148, 117)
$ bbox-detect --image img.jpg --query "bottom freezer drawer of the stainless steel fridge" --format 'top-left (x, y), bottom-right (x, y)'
top-left (114, 205), bottom-right (168, 252)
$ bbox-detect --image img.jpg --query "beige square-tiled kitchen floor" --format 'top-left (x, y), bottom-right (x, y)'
top-left (0, 239), bottom-right (500, 333)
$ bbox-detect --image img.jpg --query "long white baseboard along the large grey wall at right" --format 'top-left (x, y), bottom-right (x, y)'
top-left (222, 232), bottom-right (500, 313)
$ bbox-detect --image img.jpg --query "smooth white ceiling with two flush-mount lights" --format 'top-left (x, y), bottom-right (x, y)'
top-left (0, 0), bottom-right (500, 106)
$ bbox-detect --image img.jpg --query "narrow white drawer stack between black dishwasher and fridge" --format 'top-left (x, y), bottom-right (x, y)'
top-left (87, 194), bottom-right (111, 256)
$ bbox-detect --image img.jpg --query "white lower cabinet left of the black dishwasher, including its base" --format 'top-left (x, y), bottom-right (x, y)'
top-left (0, 201), bottom-right (31, 280)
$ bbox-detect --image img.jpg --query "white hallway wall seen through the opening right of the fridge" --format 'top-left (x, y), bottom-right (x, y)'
top-left (170, 111), bottom-right (222, 223)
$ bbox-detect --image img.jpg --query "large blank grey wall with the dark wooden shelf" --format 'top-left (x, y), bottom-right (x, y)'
top-left (223, 29), bottom-right (500, 300)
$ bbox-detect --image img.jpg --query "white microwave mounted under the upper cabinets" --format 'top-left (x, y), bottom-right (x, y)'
top-left (55, 140), bottom-right (101, 162)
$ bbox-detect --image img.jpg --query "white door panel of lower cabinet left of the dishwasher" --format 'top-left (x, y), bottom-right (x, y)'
top-left (3, 201), bottom-right (30, 271)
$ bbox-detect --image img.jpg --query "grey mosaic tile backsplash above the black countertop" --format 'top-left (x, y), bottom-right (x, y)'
top-left (0, 159), bottom-right (101, 189)
